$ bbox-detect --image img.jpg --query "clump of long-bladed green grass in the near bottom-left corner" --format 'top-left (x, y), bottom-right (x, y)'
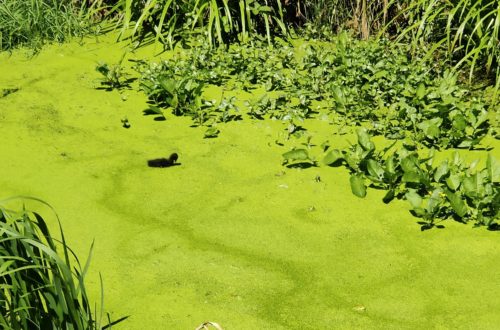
top-left (0, 200), bottom-right (124, 329)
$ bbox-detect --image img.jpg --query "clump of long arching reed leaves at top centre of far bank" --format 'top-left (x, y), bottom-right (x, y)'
top-left (113, 0), bottom-right (287, 47)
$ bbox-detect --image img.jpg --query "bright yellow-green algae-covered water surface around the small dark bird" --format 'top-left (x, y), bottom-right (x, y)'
top-left (0, 37), bottom-right (500, 329)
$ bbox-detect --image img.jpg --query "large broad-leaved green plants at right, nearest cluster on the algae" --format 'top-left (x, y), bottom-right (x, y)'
top-left (323, 128), bottom-right (500, 229)
